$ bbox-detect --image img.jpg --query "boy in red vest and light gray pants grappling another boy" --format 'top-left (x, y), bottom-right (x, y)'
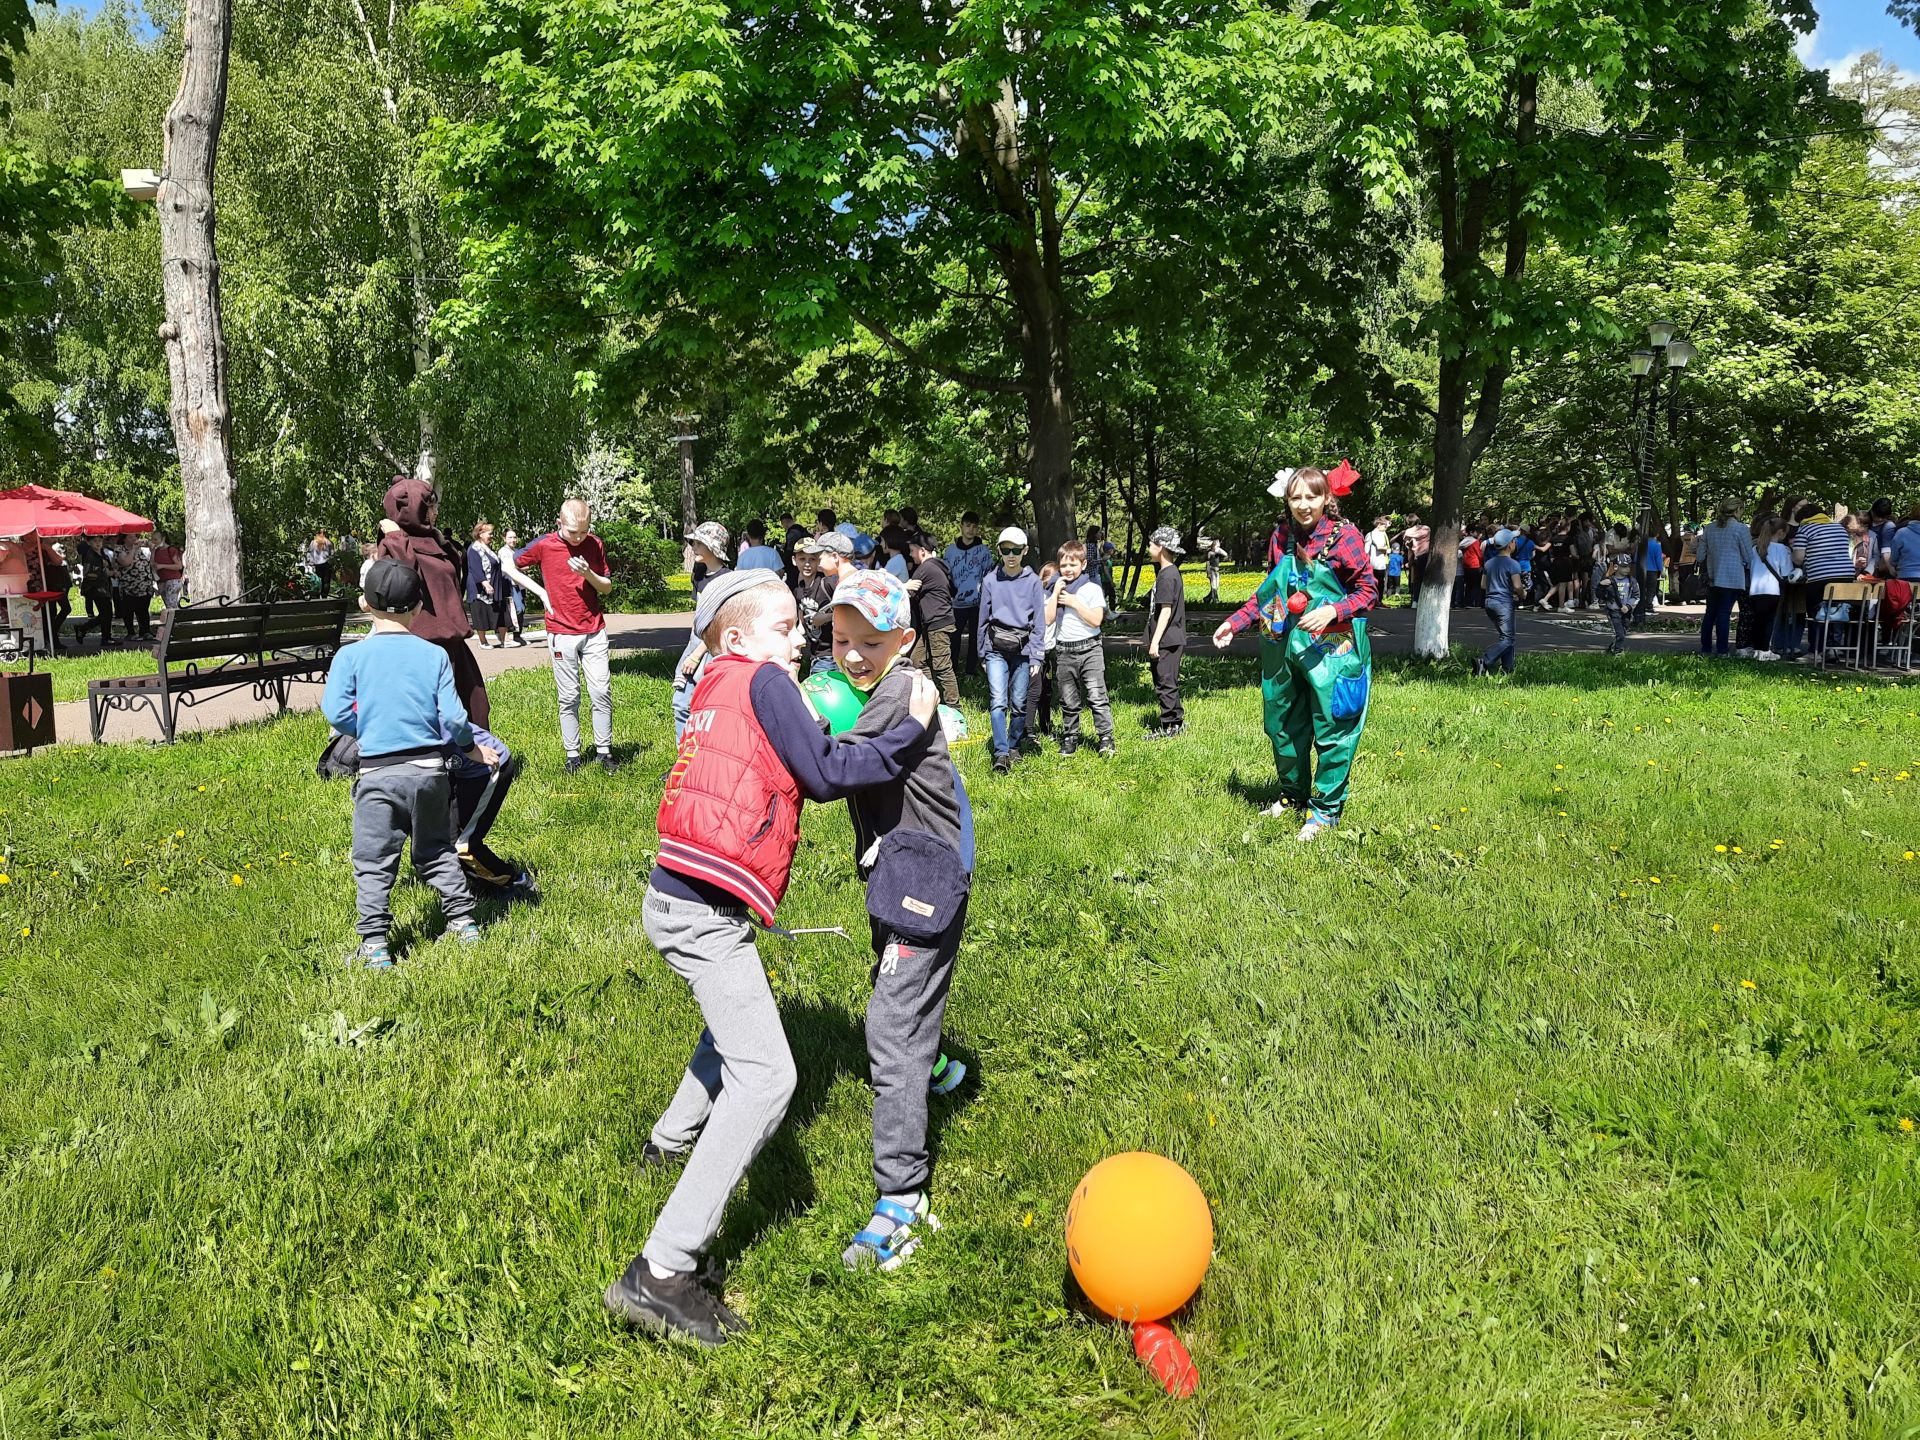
top-left (605, 570), bottom-right (939, 1346)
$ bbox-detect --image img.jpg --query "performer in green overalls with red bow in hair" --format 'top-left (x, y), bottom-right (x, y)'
top-left (1213, 461), bottom-right (1380, 841)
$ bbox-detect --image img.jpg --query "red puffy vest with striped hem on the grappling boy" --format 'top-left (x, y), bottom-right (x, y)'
top-left (657, 655), bottom-right (801, 925)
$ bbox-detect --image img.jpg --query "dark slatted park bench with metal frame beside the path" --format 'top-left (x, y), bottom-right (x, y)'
top-left (86, 597), bottom-right (348, 745)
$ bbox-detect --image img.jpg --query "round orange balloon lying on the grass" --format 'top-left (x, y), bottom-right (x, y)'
top-left (1068, 1150), bottom-right (1213, 1323)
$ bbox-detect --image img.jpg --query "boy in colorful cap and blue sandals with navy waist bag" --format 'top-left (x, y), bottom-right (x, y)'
top-left (833, 570), bottom-right (973, 1271)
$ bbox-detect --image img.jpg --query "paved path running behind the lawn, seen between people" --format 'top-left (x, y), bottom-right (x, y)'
top-left (41, 605), bottom-right (1728, 745)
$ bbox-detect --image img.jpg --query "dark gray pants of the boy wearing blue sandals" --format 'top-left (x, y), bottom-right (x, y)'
top-left (866, 900), bottom-right (966, 1194)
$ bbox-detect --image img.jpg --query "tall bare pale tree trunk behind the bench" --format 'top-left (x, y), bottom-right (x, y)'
top-left (157, 0), bottom-right (242, 599)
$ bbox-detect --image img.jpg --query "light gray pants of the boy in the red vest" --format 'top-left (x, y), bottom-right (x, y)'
top-left (641, 887), bottom-right (798, 1273)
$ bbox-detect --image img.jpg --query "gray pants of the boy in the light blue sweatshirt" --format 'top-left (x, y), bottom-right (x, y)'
top-left (353, 762), bottom-right (474, 941)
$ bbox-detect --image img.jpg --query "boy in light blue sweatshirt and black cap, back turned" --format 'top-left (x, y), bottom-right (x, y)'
top-left (321, 559), bottom-right (499, 970)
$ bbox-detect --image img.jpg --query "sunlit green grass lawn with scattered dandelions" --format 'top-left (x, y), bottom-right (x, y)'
top-left (0, 655), bottom-right (1920, 1440)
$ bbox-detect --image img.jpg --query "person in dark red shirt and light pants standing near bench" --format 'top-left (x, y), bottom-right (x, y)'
top-left (501, 499), bottom-right (614, 774)
